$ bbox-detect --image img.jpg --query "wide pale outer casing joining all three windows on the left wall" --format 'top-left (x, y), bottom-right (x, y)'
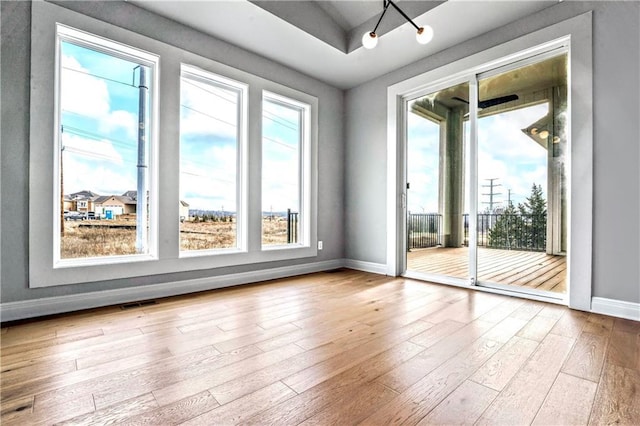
top-left (29, 2), bottom-right (318, 288)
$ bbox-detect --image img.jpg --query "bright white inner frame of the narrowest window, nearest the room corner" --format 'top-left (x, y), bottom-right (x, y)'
top-left (260, 90), bottom-right (312, 251)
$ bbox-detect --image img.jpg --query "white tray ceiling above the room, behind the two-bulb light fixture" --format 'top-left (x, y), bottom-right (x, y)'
top-left (130, 0), bottom-right (559, 89)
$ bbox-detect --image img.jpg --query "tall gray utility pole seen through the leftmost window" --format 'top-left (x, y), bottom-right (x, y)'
top-left (134, 65), bottom-right (149, 253)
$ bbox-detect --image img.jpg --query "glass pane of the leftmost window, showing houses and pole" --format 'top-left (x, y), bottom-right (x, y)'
top-left (59, 41), bottom-right (153, 259)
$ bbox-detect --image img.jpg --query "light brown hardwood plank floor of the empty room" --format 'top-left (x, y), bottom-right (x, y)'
top-left (0, 270), bottom-right (640, 425)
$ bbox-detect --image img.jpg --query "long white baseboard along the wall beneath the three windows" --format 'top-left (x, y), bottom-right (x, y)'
top-left (0, 259), bottom-right (344, 322)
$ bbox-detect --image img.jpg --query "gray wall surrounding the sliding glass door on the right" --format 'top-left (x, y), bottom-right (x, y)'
top-left (345, 2), bottom-right (640, 303)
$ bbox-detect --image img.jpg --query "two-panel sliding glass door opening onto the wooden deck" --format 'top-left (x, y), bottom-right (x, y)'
top-left (405, 50), bottom-right (569, 298)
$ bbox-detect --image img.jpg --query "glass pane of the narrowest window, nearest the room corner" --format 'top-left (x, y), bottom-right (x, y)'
top-left (262, 97), bottom-right (303, 245)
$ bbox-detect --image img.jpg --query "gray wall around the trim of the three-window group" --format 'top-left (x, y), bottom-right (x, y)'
top-left (0, 1), bottom-right (344, 303)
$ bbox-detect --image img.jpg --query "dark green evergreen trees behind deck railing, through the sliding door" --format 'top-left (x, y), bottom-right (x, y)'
top-left (488, 183), bottom-right (547, 250)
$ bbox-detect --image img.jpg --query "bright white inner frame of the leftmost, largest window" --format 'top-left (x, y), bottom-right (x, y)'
top-left (51, 23), bottom-right (160, 269)
